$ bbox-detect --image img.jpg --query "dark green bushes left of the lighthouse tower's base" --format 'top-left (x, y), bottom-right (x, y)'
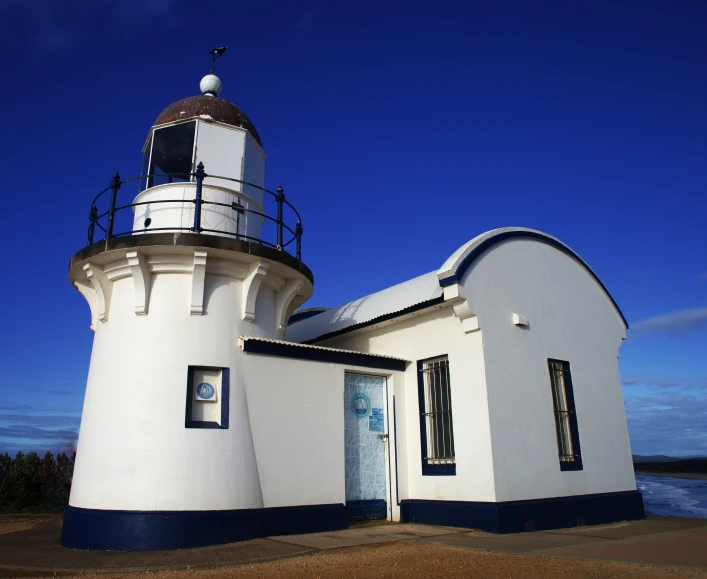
top-left (0, 452), bottom-right (76, 513)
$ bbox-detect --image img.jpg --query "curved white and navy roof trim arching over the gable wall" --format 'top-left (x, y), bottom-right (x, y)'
top-left (437, 227), bottom-right (628, 329)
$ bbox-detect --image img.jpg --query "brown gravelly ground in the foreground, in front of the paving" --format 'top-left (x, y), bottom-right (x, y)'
top-left (68, 542), bottom-right (707, 579)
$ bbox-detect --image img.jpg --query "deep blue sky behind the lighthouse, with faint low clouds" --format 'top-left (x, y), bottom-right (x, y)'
top-left (0, 0), bottom-right (707, 455)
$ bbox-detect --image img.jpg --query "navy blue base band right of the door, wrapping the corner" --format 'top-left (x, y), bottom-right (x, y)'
top-left (400, 491), bottom-right (645, 533)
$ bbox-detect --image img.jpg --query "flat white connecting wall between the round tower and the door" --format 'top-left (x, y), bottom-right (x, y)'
top-left (242, 354), bottom-right (402, 519)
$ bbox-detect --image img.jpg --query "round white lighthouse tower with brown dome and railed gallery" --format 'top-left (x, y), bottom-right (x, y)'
top-left (62, 61), bottom-right (313, 549)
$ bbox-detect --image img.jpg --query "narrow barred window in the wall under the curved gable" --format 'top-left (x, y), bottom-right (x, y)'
top-left (547, 360), bottom-right (582, 470)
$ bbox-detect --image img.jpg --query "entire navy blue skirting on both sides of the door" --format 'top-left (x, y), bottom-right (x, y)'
top-left (61, 491), bottom-right (645, 551)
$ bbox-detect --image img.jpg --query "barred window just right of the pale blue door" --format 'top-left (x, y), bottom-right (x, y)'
top-left (417, 356), bottom-right (456, 475)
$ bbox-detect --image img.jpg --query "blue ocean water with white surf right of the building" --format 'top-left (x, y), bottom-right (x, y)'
top-left (636, 475), bottom-right (707, 519)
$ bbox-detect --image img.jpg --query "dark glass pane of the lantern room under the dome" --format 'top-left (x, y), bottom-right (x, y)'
top-left (148, 122), bottom-right (196, 187)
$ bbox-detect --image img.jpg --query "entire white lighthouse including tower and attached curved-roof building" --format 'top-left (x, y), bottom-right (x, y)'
top-left (62, 73), bottom-right (643, 549)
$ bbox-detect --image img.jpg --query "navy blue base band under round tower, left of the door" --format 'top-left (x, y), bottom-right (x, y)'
top-left (61, 504), bottom-right (348, 551)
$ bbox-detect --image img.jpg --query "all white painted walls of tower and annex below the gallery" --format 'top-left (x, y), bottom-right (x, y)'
top-left (70, 220), bottom-right (635, 519)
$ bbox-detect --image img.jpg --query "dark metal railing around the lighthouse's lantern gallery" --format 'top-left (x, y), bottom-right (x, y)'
top-left (88, 163), bottom-right (302, 261)
